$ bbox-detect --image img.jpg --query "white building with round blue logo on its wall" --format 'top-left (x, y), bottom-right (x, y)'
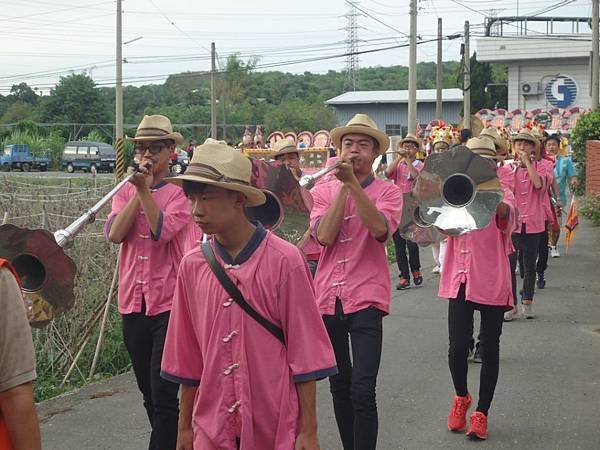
top-left (477, 34), bottom-right (592, 111)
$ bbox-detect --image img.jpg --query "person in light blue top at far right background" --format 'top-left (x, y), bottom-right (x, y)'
top-left (546, 134), bottom-right (579, 258)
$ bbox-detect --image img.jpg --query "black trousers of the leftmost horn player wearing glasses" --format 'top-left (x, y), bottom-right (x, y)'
top-left (122, 311), bottom-right (179, 450)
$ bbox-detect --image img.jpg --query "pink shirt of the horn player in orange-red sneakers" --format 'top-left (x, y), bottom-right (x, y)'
top-left (438, 167), bottom-right (516, 309)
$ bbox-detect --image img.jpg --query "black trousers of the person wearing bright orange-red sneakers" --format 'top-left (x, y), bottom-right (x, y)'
top-left (448, 284), bottom-right (505, 414)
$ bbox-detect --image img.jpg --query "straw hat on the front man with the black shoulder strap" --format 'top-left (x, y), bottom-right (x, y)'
top-left (165, 143), bottom-right (266, 206)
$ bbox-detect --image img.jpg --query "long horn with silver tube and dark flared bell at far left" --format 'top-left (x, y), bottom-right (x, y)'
top-left (0, 174), bottom-right (134, 327)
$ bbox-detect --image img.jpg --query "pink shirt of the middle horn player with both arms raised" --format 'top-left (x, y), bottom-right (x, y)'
top-left (310, 176), bottom-right (402, 315)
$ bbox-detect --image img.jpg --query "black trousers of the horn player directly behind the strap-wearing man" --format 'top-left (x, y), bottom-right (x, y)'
top-left (323, 299), bottom-right (384, 450)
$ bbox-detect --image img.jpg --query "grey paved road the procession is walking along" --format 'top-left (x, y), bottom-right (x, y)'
top-left (40, 220), bottom-right (600, 450)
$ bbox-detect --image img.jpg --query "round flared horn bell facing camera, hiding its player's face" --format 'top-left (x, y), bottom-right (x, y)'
top-left (413, 145), bottom-right (504, 236)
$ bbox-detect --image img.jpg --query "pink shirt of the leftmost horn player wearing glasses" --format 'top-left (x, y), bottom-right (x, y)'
top-left (104, 182), bottom-right (201, 316)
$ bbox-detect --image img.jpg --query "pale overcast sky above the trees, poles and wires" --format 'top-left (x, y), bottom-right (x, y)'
top-left (0, 0), bottom-right (591, 95)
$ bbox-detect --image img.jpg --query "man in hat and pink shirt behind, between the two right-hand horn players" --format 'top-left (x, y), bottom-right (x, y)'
top-left (385, 134), bottom-right (424, 290)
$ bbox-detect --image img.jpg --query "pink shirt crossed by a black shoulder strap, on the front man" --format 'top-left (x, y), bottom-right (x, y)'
top-left (161, 226), bottom-right (337, 450)
